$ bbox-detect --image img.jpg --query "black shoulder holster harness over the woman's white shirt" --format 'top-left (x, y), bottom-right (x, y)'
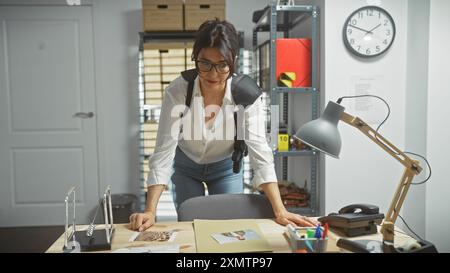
top-left (181, 69), bottom-right (262, 173)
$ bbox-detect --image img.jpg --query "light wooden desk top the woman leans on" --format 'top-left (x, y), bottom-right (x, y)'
top-left (46, 219), bottom-right (410, 253)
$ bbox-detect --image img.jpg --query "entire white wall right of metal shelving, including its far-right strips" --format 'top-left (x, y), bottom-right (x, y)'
top-left (322, 0), bottom-right (450, 252)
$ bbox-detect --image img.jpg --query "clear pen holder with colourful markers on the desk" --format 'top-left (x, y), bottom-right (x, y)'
top-left (288, 225), bottom-right (328, 253)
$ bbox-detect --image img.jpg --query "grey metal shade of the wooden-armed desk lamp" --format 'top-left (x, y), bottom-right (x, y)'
top-left (294, 101), bottom-right (345, 158)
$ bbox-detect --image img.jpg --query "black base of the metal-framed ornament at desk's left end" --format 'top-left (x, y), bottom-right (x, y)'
top-left (71, 229), bottom-right (114, 251)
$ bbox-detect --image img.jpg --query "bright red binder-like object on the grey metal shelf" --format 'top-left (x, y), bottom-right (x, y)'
top-left (276, 38), bottom-right (311, 87)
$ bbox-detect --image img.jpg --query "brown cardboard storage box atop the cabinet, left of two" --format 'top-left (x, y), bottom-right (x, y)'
top-left (142, 0), bottom-right (183, 31)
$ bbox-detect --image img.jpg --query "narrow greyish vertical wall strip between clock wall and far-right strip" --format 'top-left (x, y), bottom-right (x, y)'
top-left (399, 0), bottom-right (430, 239)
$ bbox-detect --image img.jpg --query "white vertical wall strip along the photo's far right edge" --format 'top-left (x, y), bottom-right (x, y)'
top-left (426, 0), bottom-right (450, 252)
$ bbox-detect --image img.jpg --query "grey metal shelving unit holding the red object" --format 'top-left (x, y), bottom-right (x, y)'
top-left (253, 3), bottom-right (320, 216)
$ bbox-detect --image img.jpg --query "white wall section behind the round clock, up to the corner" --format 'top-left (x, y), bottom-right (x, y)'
top-left (322, 0), bottom-right (407, 217)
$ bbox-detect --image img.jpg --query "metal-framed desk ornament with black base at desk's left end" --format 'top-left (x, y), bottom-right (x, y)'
top-left (63, 185), bottom-right (114, 252)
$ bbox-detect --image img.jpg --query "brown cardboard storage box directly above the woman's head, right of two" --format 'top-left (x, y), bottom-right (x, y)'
top-left (184, 0), bottom-right (225, 30)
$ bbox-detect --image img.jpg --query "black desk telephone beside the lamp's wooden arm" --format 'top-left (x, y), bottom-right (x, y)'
top-left (318, 204), bottom-right (384, 237)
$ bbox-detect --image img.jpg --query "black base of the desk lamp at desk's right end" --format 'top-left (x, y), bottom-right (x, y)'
top-left (336, 239), bottom-right (438, 253)
